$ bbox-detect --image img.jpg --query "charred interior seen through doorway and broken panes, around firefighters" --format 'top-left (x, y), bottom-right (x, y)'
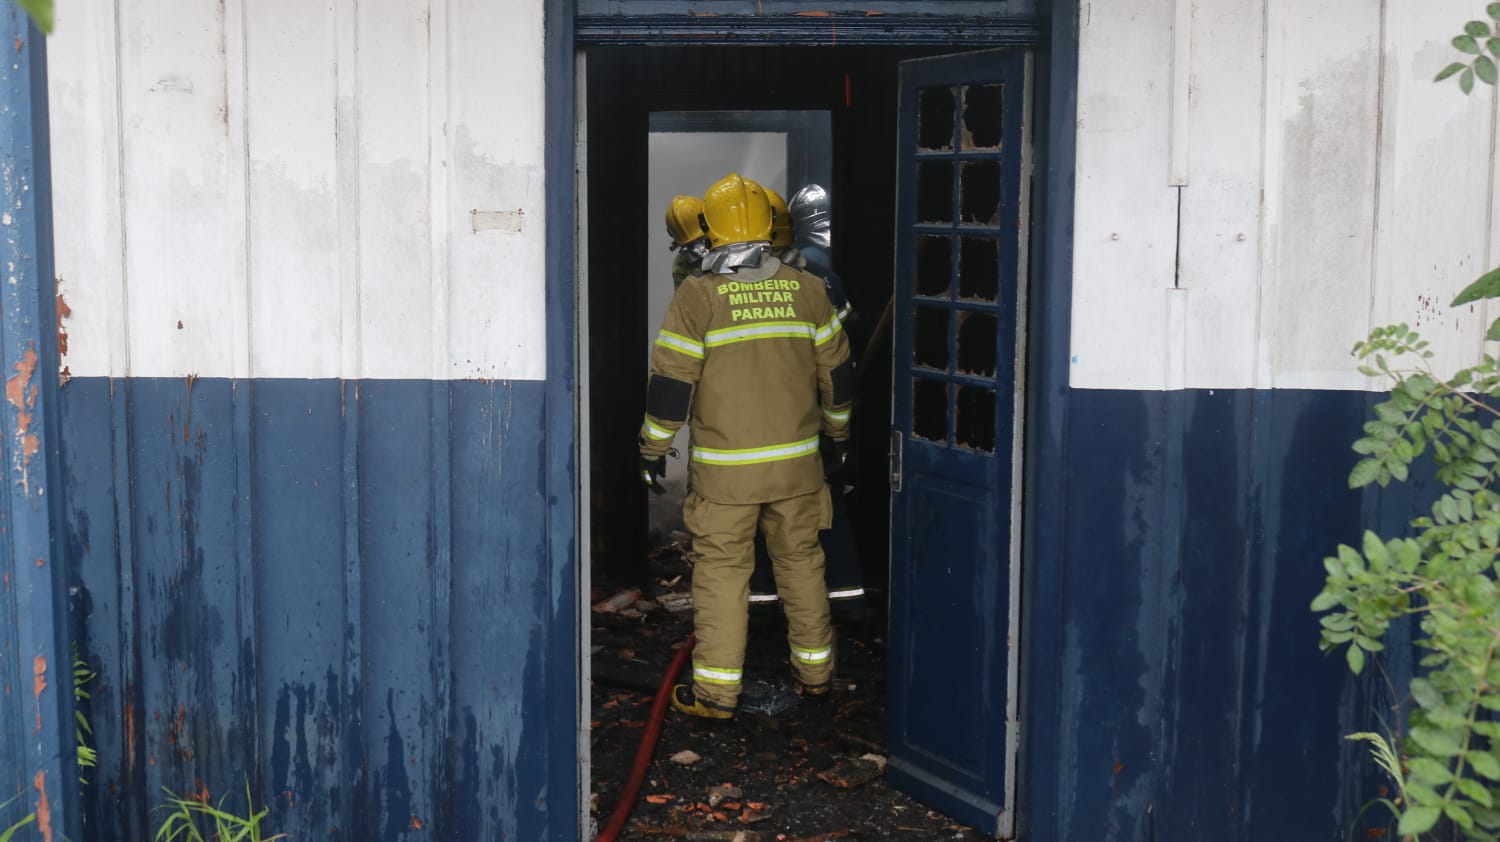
top-left (579, 47), bottom-right (1025, 839)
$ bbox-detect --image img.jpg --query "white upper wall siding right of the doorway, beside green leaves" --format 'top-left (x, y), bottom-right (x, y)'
top-left (1071, 0), bottom-right (1500, 389)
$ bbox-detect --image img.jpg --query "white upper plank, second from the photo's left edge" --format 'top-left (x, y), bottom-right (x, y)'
top-left (120, 0), bottom-right (245, 377)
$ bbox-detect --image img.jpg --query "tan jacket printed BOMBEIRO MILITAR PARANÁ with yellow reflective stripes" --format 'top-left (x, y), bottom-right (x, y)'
top-left (641, 254), bottom-right (854, 504)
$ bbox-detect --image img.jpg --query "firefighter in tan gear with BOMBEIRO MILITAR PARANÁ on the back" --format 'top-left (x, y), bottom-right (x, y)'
top-left (641, 174), bottom-right (854, 719)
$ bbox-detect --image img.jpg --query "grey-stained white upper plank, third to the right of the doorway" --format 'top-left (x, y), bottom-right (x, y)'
top-left (1259, 0), bottom-right (1382, 389)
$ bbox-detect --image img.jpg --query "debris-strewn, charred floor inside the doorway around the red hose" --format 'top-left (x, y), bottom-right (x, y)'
top-left (591, 533), bottom-right (984, 842)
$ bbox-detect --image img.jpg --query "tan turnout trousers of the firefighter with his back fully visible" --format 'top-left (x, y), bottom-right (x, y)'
top-left (683, 486), bottom-right (834, 708)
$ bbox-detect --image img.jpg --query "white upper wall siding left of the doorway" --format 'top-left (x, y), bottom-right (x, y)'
top-left (48, 0), bottom-right (546, 380)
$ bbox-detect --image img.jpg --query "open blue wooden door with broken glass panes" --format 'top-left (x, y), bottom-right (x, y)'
top-left (888, 48), bottom-right (1031, 836)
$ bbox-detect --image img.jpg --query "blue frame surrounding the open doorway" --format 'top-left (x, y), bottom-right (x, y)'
top-left (543, 0), bottom-right (1079, 839)
